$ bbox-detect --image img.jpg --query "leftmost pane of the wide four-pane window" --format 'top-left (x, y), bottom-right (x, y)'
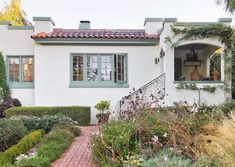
top-left (73, 55), bottom-right (83, 81)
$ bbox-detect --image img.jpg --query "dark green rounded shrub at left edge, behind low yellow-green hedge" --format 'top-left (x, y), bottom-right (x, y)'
top-left (0, 119), bottom-right (27, 151)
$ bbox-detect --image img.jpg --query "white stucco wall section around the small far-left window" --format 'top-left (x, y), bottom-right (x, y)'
top-left (0, 25), bottom-right (34, 106)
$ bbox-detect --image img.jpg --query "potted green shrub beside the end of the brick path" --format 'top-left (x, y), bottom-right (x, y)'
top-left (95, 100), bottom-right (110, 124)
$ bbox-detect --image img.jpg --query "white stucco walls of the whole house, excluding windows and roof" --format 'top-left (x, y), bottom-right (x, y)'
top-left (0, 19), bottom-right (231, 123)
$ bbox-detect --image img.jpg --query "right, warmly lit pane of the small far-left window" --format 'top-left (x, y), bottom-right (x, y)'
top-left (22, 58), bottom-right (33, 82)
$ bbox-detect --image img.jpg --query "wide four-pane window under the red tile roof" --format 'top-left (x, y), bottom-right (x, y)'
top-left (70, 54), bottom-right (128, 87)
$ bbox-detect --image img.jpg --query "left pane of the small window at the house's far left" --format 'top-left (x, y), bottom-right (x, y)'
top-left (9, 58), bottom-right (20, 82)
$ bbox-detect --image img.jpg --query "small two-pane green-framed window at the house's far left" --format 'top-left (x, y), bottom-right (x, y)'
top-left (7, 56), bottom-right (34, 88)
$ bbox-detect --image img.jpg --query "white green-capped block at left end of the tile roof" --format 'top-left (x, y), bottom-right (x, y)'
top-left (33, 17), bottom-right (55, 34)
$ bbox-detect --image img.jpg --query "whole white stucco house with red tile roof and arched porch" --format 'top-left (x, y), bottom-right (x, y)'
top-left (0, 17), bottom-right (232, 120)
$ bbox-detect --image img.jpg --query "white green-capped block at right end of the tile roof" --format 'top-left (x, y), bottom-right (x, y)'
top-left (144, 18), bottom-right (163, 34)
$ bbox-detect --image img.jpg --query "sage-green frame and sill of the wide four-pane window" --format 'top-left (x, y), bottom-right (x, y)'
top-left (69, 53), bottom-right (129, 88)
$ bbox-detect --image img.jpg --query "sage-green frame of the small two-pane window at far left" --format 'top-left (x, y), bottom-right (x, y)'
top-left (6, 55), bottom-right (35, 89)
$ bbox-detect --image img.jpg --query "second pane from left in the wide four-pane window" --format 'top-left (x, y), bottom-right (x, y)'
top-left (87, 55), bottom-right (98, 81)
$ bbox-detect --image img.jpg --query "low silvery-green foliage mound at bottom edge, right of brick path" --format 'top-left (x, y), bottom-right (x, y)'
top-left (142, 149), bottom-right (194, 167)
